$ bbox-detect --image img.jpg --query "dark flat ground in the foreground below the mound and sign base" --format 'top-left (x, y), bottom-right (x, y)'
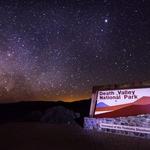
top-left (0, 122), bottom-right (150, 150)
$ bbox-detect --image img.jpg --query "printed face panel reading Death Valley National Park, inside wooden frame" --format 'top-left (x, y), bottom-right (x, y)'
top-left (95, 88), bottom-right (150, 117)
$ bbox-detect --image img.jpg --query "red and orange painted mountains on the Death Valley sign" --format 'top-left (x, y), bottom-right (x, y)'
top-left (95, 97), bottom-right (150, 118)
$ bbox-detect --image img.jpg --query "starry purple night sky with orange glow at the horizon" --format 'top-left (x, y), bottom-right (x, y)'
top-left (0, 0), bottom-right (150, 102)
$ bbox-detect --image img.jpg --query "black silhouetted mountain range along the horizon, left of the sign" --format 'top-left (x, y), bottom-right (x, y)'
top-left (0, 99), bottom-right (91, 122)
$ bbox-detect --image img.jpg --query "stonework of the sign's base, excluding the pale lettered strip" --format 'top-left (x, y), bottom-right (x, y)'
top-left (84, 114), bottom-right (150, 139)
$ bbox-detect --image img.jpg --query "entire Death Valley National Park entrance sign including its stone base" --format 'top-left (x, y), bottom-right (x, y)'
top-left (84, 82), bottom-right (150, 138)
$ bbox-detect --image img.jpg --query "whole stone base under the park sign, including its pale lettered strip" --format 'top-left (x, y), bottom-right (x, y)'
top-left (84, 114), bottom-right (150, 139)
